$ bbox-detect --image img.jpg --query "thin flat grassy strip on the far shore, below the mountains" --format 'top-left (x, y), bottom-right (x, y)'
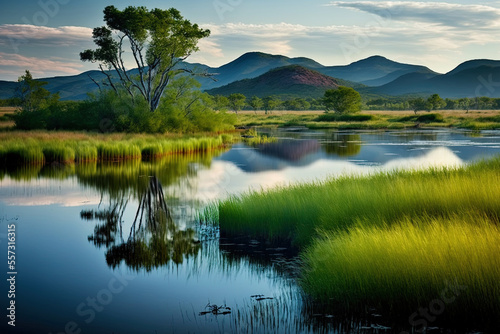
top-left (238, 110), bottom-right (500, 130)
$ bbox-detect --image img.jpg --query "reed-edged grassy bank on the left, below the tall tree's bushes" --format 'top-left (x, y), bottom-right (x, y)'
top-left (0, 131), bottom-right (233, 165)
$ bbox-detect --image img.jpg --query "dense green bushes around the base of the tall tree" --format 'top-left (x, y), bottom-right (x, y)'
top-left (14, 76), bottom-right (236, 133)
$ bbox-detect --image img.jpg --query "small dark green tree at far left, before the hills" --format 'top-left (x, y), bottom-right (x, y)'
top-left (16, 70), bottom-right (59, 112)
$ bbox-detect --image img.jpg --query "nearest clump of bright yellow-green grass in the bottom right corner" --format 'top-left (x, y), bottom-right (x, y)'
top-left (302, 215), bottom-right (500, 320)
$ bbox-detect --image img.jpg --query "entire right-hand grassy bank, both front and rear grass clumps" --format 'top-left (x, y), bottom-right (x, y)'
top-left (215, 158), bottom-right (500, 319)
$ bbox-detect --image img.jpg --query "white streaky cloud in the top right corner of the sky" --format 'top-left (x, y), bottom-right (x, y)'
top-left (328, 1), bottom-right (500, 29)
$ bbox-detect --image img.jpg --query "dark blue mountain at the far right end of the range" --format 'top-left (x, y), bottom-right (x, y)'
top-left (368, 60), bottom-right (500, 98)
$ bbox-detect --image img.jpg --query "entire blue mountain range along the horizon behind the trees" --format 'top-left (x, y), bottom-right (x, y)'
top-left (0, 52), bottom-right (500, 100)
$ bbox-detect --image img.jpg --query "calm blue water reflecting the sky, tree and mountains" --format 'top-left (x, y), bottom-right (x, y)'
top-left (0, 129), bottom-right (500, 333)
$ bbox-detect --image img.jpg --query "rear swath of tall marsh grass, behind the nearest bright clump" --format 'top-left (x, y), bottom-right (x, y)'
top-left (219, 158), bottom-right (500, 246)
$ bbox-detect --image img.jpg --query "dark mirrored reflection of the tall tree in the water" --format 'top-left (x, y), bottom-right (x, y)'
top-left (80, 176), bottom-right (200, 271)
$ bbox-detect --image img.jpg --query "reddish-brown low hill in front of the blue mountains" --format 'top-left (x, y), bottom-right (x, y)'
top-left (207, 65), bottom-right (339, 98)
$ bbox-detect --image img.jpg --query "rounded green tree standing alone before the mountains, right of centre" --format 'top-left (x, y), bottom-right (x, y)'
top-left (323, 86), bottom-right (361, 114)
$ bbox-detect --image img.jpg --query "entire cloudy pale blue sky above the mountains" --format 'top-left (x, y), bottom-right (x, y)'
top-left (0, 0), bottom-right (500, 80)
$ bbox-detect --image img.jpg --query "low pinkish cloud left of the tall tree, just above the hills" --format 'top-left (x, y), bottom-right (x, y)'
top-left (0, 52), bottom-right (83, 77)
